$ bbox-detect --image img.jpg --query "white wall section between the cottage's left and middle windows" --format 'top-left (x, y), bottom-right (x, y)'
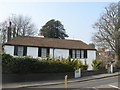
top-left (27, 47), bottom-right (38, 58)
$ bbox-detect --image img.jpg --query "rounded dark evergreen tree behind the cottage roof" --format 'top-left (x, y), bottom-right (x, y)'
top-left (40, 19), bottom-right (68, 39)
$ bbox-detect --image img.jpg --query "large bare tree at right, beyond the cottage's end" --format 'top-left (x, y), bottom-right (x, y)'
top-left (93, 3), bottom-right (120, 60)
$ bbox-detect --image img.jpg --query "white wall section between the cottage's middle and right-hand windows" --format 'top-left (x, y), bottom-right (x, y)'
top-left (50, 48), bottom-right (69, 58)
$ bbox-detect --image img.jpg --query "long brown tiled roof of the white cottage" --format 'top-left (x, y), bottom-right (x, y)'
top-left (5, 36), bottom-right (96, 50)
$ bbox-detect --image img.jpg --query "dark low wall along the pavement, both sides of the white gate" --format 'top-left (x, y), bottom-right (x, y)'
top-left (2, 70), bottom-right (107, 84)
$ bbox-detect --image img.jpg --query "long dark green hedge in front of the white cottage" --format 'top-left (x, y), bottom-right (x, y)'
top-left (2, 54), bottom-right (88, 73)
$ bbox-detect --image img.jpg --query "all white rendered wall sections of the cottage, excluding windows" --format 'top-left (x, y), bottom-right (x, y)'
top-left (4, 45), bottom-right (96, 70)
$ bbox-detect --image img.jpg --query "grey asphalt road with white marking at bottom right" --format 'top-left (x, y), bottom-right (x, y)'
top-left (27, 76), bottom-right (120, 90)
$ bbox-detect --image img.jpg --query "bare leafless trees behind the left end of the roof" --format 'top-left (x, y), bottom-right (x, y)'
top-left (0, 15), bottom-right (36, 43)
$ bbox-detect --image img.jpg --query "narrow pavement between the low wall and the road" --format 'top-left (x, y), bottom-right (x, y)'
top-left (2, 72), bottom-right (120, 88)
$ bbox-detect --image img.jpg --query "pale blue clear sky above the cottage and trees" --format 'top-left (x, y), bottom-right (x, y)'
top-left (0, 1), bottom-right (118, 44)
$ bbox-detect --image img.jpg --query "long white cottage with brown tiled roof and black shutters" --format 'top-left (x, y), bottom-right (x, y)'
top-left (4, 36), bottom-right (96, 70)
